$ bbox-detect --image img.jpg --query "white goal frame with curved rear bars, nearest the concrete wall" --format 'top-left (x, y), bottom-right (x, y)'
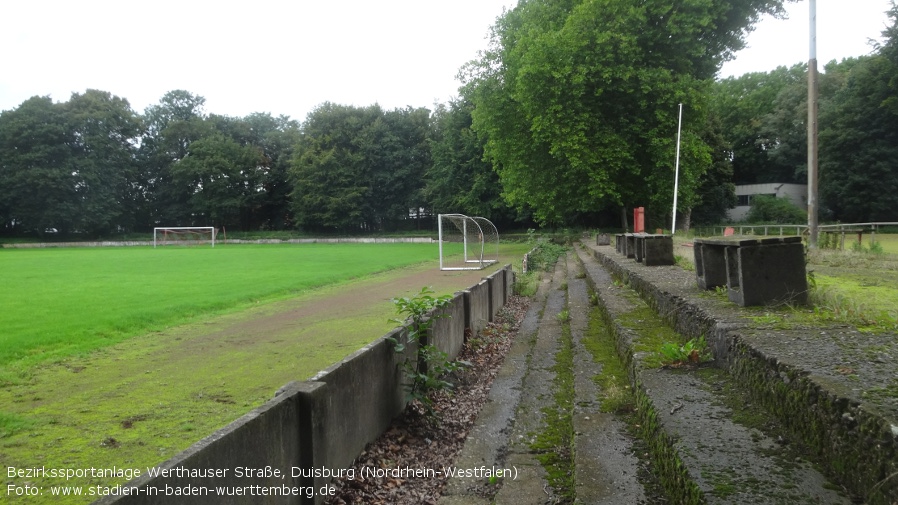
top-left (437, 214), bottom-right (499, 270)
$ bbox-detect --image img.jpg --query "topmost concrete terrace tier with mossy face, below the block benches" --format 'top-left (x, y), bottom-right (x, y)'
top-left (584, 239), bottom-right (898, 505)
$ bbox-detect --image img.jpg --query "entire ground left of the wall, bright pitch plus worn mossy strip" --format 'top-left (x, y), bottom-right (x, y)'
top-left (0, 240), bottom-right (528, 503)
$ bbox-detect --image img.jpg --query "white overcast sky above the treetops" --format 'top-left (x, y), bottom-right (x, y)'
top-left (0, 0), bottom-right (890, 120)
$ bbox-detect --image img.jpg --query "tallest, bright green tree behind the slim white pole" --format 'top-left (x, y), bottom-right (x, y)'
top-left (466, 0), bottom-right (782, 223)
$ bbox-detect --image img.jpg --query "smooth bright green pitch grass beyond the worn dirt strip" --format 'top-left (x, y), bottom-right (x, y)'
top-left (0, 244), bottom-right (437, 369)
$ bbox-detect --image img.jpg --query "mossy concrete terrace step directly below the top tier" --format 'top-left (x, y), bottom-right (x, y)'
top-left (577, 242), bottom-right (851, 504)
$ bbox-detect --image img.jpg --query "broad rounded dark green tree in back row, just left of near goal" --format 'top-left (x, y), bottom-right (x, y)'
top-left (290, 103), bottom-right (430, 232)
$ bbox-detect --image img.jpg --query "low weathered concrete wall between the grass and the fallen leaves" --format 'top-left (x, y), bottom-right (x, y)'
top-left (96, 265), bottom-right (513, 505)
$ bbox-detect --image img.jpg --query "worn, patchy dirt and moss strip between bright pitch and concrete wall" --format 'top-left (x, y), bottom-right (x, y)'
top-left (0, 263), bottom-right (502, 503)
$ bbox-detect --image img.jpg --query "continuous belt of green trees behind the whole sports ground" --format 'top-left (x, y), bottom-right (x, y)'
top-left (0, 0), bottom-right (898, 236)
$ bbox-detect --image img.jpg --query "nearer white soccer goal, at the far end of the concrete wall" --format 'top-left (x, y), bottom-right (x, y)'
top-left (437, 214), bottom-right (499, 270)
